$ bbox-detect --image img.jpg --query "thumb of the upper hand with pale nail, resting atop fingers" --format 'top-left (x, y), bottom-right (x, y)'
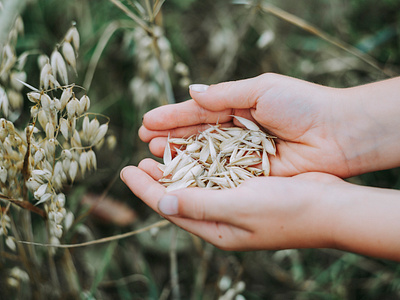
top-left (189, 74), bottom-right (266, 111)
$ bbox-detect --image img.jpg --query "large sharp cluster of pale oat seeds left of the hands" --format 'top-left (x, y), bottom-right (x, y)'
top-left (26, 27), bottom-right (108, 243)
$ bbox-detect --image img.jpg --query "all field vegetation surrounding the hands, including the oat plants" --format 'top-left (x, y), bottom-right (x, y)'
top-left (0, 0), bottom-right (400, 300)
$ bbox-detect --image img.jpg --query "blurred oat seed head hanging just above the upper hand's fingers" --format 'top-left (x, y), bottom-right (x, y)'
top-left (109, 0), bottom-right (175, 109)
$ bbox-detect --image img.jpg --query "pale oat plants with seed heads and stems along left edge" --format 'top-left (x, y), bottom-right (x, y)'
top-left (0, 10), bottom-right (109, 299)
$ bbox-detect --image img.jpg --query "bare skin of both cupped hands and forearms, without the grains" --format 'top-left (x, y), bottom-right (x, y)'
top-left (121, 74), bottom-right (400, 261)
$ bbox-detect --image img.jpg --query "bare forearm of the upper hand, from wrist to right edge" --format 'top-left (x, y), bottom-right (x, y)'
top-left (336, 77), bottom-right (400, 175)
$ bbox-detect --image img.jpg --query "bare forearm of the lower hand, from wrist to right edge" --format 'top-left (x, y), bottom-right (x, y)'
top-left (321, 184), bottom-right (400, 261)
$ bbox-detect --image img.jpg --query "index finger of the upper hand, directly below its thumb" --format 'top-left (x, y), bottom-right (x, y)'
top-left (143, 100), bottom-right (232, 130)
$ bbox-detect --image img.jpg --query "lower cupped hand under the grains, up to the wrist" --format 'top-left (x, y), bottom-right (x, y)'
top-left (122, 159), bottom-right (348, 250)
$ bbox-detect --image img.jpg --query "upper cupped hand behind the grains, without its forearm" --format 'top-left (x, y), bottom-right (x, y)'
top-left (139, 74), bottom-right (357, 180)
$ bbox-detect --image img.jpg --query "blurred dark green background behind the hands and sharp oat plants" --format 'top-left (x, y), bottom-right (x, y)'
top-left (0, 0), bottom-right (400, 299)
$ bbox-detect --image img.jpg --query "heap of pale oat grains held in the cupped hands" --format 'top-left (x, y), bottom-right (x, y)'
top-left (159, 116), bottom-right (276, 191)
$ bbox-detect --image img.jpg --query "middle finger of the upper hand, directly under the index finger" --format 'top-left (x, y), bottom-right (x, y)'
top-left (139, 117), bottom-right (233, 143)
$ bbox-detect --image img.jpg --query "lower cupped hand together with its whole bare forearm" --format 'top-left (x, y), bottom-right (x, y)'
top-left (121, 159), bottom-right (400, 261)
